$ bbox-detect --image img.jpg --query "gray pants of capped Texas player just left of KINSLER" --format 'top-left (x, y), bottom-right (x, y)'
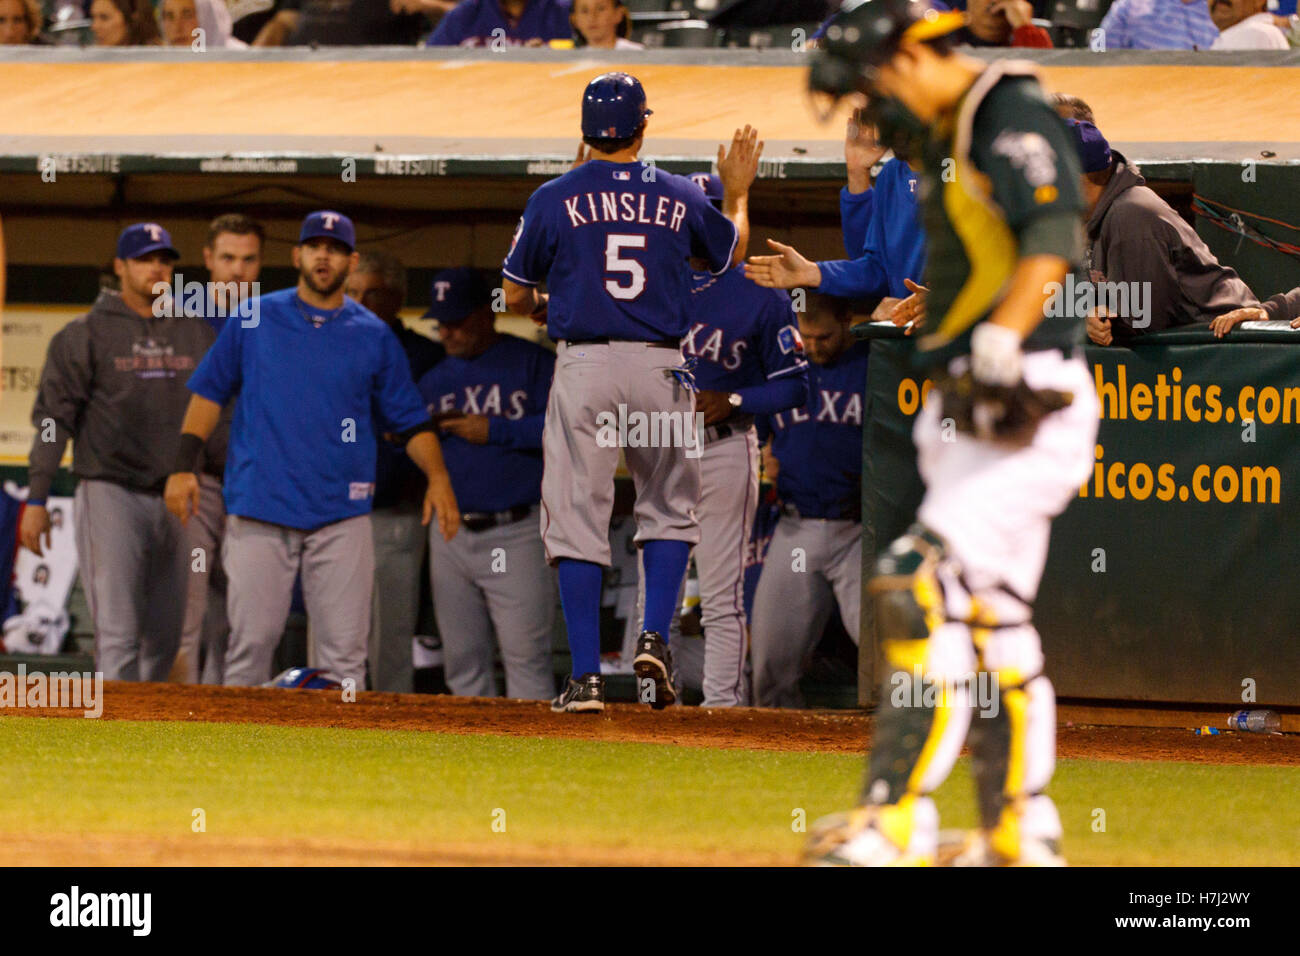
top-left (429, 514), bottom-right (556, 700)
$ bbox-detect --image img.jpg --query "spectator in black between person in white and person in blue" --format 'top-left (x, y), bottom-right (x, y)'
top-left (252, 0), bottom-right (428, 47)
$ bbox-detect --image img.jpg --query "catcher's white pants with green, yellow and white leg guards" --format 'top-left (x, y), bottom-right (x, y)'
top-left (863, 351), bottom-right (1097, 857)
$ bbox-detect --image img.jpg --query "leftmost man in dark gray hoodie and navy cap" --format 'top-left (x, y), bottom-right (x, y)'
top-left (20, 222), bottom-right (215, 680)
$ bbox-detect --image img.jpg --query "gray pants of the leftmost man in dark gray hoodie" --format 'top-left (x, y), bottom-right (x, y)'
top-left (74, 480), bottom-right (190, 680)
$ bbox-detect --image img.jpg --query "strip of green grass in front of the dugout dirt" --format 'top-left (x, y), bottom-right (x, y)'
top-left (0, 717), bottom-right (1300, 865)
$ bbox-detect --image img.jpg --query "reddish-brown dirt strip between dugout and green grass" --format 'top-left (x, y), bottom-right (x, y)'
top-left (7, 683), bottom-right (1300, 766)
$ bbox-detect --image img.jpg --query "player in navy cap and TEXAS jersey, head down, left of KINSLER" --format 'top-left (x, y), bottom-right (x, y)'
top-left (420, 269), bottom-right (555, 700)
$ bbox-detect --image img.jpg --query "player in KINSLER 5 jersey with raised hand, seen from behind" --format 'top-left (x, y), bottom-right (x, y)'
top-left (502, 73), bottom-right (761, 711)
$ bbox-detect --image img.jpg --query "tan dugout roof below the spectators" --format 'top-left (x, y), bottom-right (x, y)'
top-left (0, 47), bottom-right (1300, 179)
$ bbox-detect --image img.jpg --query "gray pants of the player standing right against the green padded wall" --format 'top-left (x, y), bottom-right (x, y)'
top-left (750, 515), bottom-right (862, 708)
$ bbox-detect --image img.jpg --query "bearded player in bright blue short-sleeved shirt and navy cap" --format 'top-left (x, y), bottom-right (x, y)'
top-left (166, 209), bottom-right (460, 688)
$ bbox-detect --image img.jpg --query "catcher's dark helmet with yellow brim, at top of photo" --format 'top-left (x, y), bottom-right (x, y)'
top-left (809, 0), bottom-right (966, 98)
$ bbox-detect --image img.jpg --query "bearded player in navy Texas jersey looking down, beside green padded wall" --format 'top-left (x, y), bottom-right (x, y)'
top-left (753, 295), bottom-right (867, 708)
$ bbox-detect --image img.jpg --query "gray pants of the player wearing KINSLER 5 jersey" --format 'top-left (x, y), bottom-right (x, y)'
top-left (538, 342), bottom-right (702, 567)
